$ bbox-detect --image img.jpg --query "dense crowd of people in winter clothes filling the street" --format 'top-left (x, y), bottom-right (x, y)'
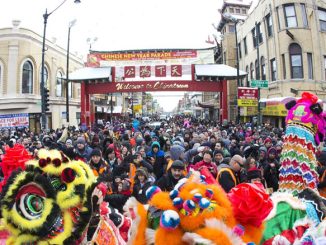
top-left (0, 116), bottom-right (326, 209)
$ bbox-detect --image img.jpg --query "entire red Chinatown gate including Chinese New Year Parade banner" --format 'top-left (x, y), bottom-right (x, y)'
top-left (69, 49), bottom-right (246, 126)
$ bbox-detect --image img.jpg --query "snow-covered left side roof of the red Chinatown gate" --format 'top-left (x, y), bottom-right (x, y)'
top-left (69, 67), bottom-right (112, 82)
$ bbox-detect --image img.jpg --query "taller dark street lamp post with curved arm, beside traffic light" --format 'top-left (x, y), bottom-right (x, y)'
top-left (40, 0), bottom-right (80, 129)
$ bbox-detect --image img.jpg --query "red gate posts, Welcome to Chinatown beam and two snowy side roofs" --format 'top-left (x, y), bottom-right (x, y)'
top-left (69, 64), bottom-right (245, 126)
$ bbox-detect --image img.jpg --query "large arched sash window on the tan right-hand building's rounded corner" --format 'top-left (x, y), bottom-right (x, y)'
top-left (289, 43), bottom-right (303, 78)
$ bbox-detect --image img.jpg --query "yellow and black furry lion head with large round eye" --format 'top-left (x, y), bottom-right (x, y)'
top-left (0, 149), bottom-right (130, 245)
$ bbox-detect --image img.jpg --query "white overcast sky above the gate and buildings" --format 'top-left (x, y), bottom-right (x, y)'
top-left (0, 0), bottom-right (257, 112)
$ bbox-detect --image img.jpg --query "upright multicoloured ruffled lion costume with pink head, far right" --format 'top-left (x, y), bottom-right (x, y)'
top-left (262, 92), bottom-right (326, 245)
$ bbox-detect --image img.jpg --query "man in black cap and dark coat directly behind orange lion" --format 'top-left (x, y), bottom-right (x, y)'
top-left (155, 160), bottom-right (185, 191)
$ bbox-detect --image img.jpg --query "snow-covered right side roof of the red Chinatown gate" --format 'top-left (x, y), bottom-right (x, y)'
top-left (195, 64), bottom-right (247, 80)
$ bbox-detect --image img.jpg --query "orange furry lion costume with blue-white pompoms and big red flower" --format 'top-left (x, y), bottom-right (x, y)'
top-left (124, 172), bottom-right (272, 245)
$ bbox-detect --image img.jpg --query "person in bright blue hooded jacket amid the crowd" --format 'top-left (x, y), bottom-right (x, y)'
top-left (146, 141), bottom-right (167, 179)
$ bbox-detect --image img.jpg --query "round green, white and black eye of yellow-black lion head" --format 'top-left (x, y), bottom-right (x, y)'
top-left (14, 193), bottom-right (45, 220)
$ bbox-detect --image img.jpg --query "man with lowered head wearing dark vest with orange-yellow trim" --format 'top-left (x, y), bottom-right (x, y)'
top-left (217, 155), bottom-right (243, 193)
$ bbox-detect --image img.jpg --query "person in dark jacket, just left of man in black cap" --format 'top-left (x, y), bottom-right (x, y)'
top-left (132, 167), bottom-right (151, 204)
